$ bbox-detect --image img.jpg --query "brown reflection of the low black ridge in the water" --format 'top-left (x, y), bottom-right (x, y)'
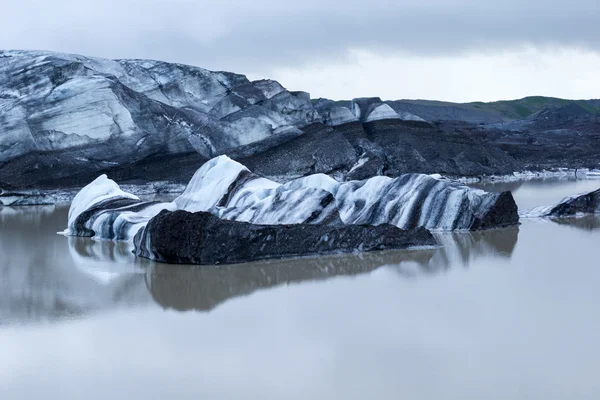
top-left (141, 249), bottom-right (435, 311)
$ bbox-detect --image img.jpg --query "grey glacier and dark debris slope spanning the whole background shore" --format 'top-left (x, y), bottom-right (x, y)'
top-left (0, 50), bottom-right (600, 205)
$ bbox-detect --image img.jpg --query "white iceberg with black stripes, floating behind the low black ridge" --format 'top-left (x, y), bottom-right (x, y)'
top-left (65, 156), bottom-right (518, 240)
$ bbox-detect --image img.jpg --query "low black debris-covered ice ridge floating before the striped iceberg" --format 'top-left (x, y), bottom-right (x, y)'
top-left (134, 211), bottom-right (437, 264)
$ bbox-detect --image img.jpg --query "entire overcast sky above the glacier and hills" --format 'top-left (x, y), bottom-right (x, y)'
top-left (0, 0), bottom-right (600, 101)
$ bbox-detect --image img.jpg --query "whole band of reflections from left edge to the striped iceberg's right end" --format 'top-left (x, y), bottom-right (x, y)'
top-left (0, 207), bottom-right (519, 322)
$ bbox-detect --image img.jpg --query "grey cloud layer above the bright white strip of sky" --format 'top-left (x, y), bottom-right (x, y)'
top-left (0, 0), bottom-right (600, 75)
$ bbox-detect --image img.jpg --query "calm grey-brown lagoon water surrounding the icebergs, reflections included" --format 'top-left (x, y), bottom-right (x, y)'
top-left (0, 180), bottom-right (600, 400)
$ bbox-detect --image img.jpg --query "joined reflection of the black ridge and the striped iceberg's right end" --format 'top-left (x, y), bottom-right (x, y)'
top-left (139, 228), bottom-right (519, 311)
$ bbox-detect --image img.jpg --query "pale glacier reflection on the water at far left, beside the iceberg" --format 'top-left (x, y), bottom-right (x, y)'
top-left (0, 207), bottom-right (151, 324)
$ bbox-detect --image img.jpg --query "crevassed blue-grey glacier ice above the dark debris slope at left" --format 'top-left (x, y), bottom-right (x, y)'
top-left (0, 51), bottom-right (321, 170)
